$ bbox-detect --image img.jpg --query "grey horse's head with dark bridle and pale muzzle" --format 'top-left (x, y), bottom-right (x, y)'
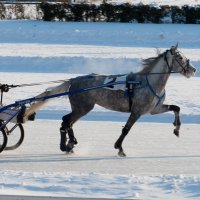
top-left (169, 43), bottom-right (196, 78)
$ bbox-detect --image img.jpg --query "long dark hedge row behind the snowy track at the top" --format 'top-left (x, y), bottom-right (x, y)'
top-left (0, 2), bottom-right (200, 24)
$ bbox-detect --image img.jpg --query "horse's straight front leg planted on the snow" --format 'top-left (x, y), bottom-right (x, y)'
top-left (114, 114), bottom-right (140, 157)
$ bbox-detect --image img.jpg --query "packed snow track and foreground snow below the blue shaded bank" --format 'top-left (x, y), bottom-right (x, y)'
top-left (0, 120), bottom-right (200, 200)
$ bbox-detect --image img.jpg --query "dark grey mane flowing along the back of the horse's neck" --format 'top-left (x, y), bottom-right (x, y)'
top-left (139, 50), bottom-right (166, 74)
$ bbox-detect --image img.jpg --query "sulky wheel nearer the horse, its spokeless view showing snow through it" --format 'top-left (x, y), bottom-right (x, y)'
top-left (4, 123), bottom-right (24, 150)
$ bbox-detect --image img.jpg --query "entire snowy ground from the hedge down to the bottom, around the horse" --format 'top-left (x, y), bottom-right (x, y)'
top-left (0, 21), bottom-right (200, 200)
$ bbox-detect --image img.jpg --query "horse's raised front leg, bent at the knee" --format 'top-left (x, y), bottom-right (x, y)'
top-left (151, 105), bottom-right (181, 137)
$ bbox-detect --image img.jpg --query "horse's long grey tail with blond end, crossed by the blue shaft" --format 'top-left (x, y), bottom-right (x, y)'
top-left (24, 81), bottom-right (71, 121)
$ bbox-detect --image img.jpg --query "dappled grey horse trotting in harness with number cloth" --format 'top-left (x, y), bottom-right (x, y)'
top-left (27, 45), bottom-right (196, 156)
